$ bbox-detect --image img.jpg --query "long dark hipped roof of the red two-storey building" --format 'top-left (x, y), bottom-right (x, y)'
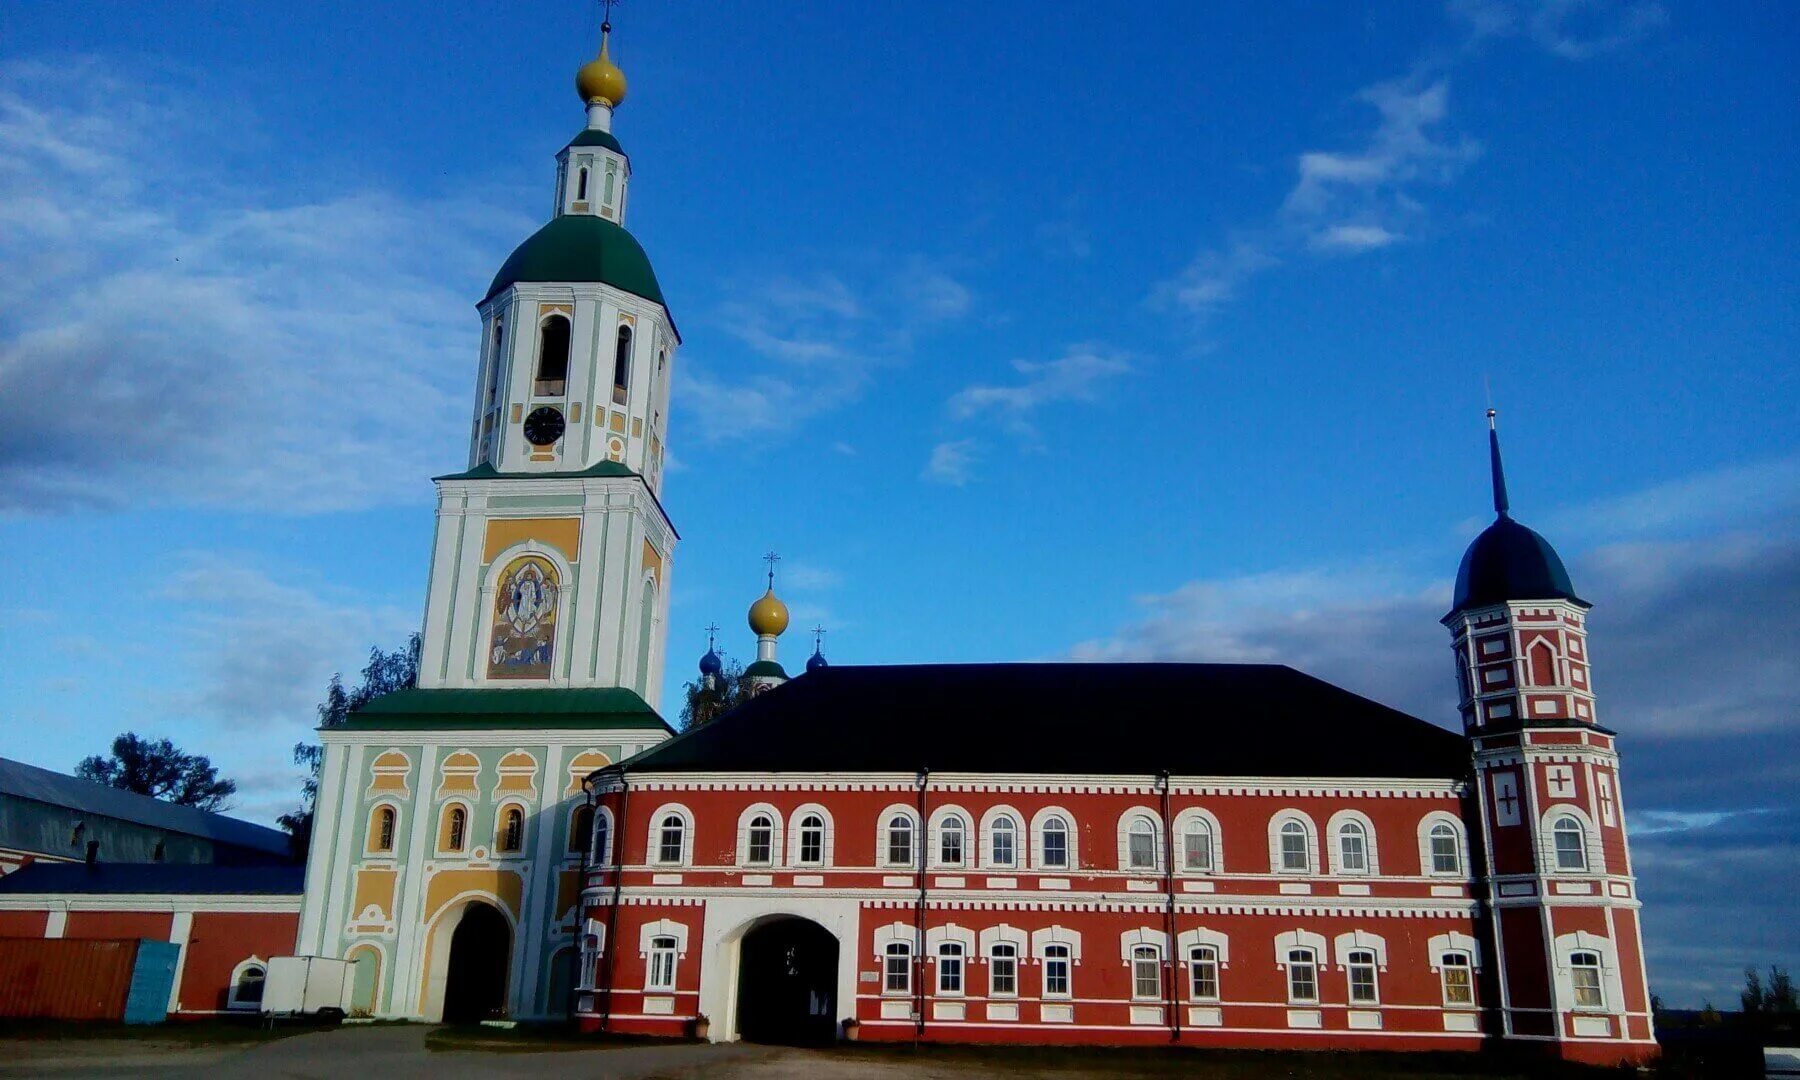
top-left (623, 662), bottom-right (1469, 779)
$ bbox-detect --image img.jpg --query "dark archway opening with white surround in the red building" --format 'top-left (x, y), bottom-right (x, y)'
top-left (738, 918), bottom-right (837, 1046)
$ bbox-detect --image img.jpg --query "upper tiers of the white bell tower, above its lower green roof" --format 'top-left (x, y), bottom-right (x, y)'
top-left (419, 22), bottom-right (680, 706)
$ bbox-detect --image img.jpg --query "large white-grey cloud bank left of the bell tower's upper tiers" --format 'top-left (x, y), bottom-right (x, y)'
top-left (0, 61), bottom-right (529, 513)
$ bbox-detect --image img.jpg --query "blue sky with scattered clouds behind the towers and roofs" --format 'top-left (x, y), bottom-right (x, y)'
top-left (0, 0), bottom-right (1800, 1003)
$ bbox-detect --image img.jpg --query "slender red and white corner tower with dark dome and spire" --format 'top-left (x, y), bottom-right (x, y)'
top-left (1444, 410), bottom-right (1656, 1064)
